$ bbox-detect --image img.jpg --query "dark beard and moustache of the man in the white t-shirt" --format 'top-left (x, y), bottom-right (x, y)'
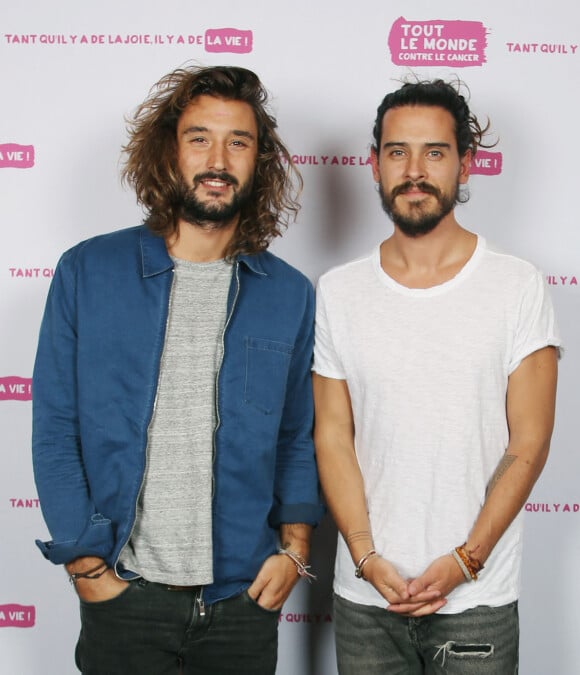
top-left (379, 181), bottom-right (460, 237)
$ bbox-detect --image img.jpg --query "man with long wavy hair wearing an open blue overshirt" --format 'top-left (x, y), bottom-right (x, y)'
top-left (33, 67), bottom-right (321, 675)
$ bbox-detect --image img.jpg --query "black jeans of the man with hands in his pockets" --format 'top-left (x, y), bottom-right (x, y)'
top-left (76, 580), bottom-right (280, 675)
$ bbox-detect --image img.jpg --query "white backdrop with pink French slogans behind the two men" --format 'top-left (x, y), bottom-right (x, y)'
top-left (0, 0), bottom-right (580, 675)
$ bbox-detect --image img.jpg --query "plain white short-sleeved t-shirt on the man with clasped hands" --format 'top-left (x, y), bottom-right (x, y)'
top-left (313, 237), bottom-right (561, 613)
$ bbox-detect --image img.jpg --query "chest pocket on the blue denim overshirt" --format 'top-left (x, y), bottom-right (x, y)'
top-left (244, 337), bottom-right (294, 415)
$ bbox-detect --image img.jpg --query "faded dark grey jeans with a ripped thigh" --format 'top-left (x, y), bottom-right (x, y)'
top-left (334, 595), bottom-right (519, 675)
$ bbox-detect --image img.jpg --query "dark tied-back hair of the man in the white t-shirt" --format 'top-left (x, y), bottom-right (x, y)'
top-left (373, 80), bottom-right (496, 157)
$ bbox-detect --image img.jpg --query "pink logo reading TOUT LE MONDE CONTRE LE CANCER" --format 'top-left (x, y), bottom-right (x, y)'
top-left (389, 16), bottom-right (488, 68)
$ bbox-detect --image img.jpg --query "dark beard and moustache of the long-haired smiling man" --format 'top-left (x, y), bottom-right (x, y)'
top-left (178, 171), bottom-right (252, 230)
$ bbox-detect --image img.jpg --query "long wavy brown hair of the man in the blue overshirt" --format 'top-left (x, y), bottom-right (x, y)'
top-left (121, 66), bottom-right (302, 258)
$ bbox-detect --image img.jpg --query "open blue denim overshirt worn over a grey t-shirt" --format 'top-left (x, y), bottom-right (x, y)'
top-left (33, 226), bottom-right (322, 603)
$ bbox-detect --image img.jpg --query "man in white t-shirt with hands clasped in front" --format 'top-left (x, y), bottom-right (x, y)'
top-left (314, 80), bottom-right (560, 675)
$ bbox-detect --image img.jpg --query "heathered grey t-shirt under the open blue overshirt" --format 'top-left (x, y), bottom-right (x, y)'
top-left (120, 259), bottom-right (232, 585)
